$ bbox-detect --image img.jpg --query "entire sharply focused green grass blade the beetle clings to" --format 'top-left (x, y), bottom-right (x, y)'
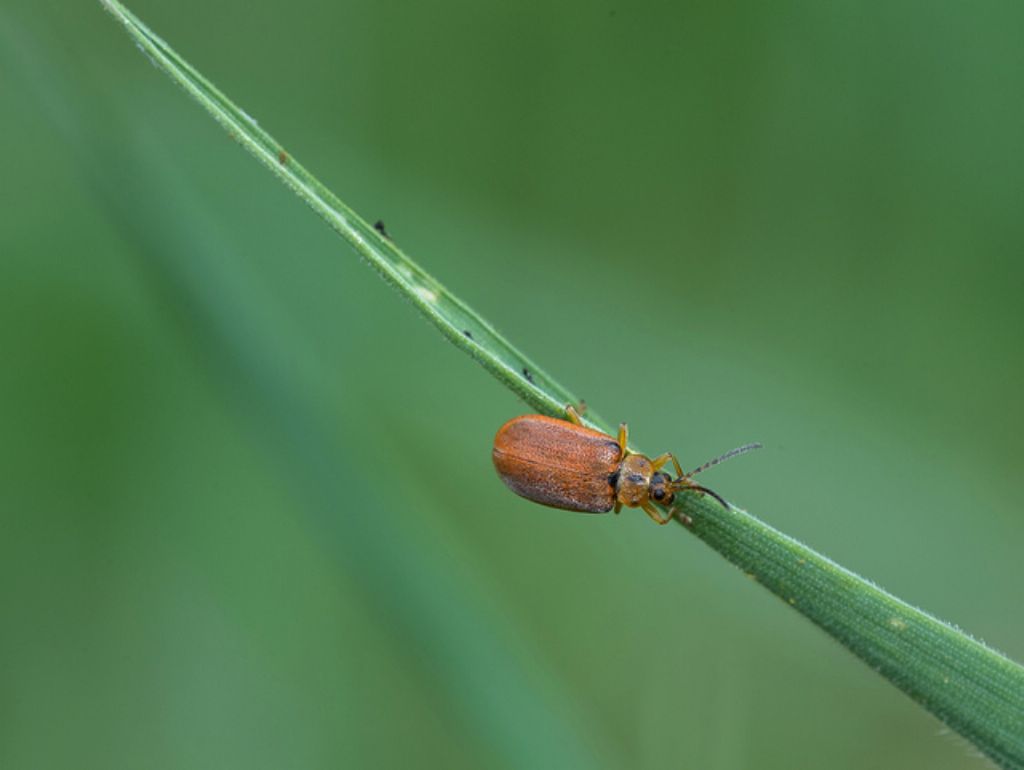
top-left (101, 0), bottom-right (1024, 768)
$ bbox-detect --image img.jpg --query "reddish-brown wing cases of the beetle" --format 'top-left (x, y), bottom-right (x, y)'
top-left (492, 415), bottom-right (622, 513)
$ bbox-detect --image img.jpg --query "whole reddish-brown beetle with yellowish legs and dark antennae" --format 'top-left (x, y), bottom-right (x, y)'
top-left (492, 405), bottom-right (761, 524)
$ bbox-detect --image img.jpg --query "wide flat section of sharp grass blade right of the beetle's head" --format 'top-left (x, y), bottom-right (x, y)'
top-left (687, 500), bottom-right (1024, 768)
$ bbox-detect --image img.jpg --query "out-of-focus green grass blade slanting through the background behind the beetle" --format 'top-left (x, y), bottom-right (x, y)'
top-left (12, 11), bottom-right (622, 769)
